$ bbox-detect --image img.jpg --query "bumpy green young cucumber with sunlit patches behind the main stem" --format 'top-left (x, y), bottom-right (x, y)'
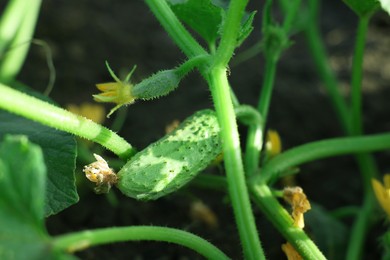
top-left (117, 110), bottom-right (222, 200)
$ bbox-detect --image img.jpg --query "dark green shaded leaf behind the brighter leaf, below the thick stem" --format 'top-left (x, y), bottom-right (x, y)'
top-left (0, 111), bottom-right (78, 216)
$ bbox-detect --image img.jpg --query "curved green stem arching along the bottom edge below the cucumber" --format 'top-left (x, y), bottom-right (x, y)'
top-left (52, 226), bottom-right (229, 260)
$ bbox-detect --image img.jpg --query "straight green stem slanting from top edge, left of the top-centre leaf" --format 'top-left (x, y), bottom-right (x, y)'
top-left (145, 0), bottom-right (207, 58)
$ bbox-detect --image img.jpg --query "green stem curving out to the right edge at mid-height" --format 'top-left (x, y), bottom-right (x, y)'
top-left (261, 134), bottom-right (390, 182)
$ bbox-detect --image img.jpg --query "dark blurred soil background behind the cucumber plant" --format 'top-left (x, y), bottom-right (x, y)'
top-left (6, 0), bottom-right (390, 259)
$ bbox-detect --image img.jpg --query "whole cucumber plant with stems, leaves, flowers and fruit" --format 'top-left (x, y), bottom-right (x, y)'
top-left (0, 0), bottom-right (390, 259)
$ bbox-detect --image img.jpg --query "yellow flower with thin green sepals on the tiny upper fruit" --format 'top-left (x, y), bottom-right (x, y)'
top-left (93, 62), bottom-right (136, 117)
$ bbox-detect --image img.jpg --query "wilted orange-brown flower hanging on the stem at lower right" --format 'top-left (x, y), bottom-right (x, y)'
top-left (283, 187), bottom-right (311, 228)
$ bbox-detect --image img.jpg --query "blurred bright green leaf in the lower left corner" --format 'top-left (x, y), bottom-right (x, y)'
top-left (0, 136), bottom-right (48, 259)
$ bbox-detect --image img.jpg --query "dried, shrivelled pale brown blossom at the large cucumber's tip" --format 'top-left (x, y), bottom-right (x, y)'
top-left (83, 154), bottom-right (118, 193)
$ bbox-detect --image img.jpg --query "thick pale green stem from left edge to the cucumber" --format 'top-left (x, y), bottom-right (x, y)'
top-left (0, 83), bottom-right (135, 159)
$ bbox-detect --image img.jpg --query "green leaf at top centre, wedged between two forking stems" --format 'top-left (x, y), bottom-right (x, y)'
top-left (168, 0), bottom-right (224, 44)
